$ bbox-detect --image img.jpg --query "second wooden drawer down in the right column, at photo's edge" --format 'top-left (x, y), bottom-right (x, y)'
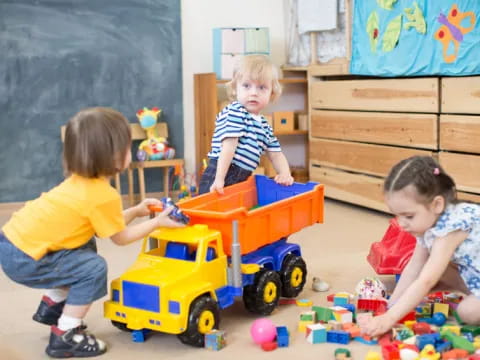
top-left (440, 114), bottom-right (480, 153)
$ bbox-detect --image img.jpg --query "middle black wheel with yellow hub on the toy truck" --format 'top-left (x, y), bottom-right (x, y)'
top-left (243, 270), bottom-right (282, 315)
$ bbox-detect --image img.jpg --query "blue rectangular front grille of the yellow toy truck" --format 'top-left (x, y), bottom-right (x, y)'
top-left (122, 281), bottom-right (160, 312)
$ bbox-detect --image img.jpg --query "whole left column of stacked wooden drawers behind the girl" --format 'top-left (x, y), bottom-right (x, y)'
top-left (309, 74), bottom-right (439, 211)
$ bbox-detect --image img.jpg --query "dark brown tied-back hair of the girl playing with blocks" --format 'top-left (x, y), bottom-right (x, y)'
top-left (383, 156), bottom-right (457, 204)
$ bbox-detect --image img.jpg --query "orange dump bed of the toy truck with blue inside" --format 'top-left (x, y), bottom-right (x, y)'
top-left (178, 175), bottom-right (324, 255)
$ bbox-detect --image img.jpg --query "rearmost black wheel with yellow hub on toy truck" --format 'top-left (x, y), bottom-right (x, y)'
top-left (280, 254), bottom-right (307, 298)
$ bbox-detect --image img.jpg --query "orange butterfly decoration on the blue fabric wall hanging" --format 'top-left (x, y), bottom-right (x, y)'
top-left (433, 4), bottom-right (475, 63)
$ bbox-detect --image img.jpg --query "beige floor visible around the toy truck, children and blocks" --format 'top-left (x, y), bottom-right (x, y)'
top-left (0, 200), bottom-right (393, 360)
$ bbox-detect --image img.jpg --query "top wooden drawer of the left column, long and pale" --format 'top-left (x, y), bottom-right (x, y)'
top-left (310, 78), bottom-right (439, 113)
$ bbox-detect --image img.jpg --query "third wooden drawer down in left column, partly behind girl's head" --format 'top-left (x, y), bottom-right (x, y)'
top-left (310, 138), bottom-right (432, 176)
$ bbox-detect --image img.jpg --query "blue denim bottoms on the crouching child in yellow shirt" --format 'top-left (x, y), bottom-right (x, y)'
top-left (0, 232), bottom-right (107, 305)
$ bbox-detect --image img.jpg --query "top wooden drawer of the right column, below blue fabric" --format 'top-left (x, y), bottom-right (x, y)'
top-left (441, 76), bottom-right (480, 114)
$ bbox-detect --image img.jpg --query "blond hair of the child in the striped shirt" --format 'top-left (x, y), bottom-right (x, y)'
top-left (226, 55), bottom-right (282, 101)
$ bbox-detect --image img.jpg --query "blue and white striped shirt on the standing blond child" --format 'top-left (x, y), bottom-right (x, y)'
top-left (208, 101), bottom-right (282, 171)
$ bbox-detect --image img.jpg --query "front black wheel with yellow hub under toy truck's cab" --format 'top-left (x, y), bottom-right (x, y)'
top-left (177, 296), bottom-right (220, 347)
